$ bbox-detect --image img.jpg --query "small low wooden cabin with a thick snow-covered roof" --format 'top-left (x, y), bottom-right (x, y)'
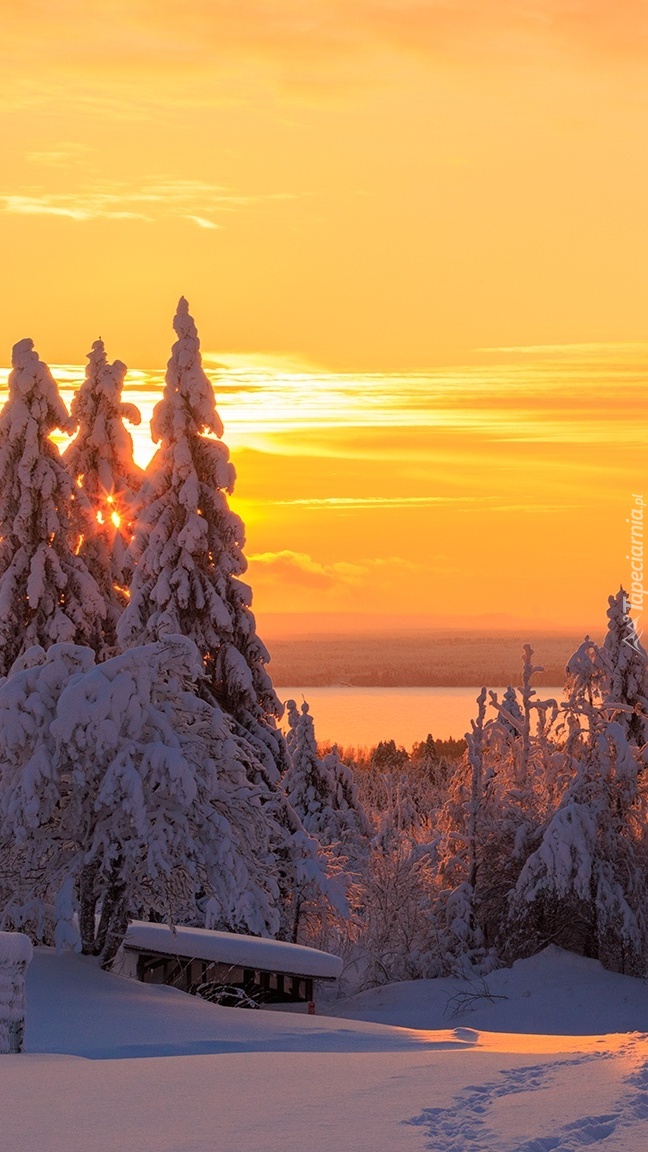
top-left (120, 920), bottom-right (342, 1003)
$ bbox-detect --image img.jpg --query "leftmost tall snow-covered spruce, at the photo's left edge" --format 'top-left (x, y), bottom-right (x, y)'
top-left (0, 340), bottom-right (105, 675)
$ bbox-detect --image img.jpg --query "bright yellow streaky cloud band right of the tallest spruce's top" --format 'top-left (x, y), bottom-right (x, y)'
top-left (214, 354), bottom-right (648, 449)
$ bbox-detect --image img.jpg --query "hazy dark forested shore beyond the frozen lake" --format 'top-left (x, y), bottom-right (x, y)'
top-left (268, 631), bottom-right (582, 688)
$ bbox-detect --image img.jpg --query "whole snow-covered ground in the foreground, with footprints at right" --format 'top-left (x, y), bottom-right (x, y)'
top-left (0, 949), bottom-right (648, 1152)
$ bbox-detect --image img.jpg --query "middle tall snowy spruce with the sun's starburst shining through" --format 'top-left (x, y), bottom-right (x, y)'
top-left (63, 340), bottom-right (143, 654)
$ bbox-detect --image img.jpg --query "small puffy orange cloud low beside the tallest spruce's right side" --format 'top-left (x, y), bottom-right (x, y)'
top-left (248, 550), bottom-right (421, 591)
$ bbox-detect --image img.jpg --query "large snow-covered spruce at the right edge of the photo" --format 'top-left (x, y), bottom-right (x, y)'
top-left (508, 603), bottom-right (648, 972)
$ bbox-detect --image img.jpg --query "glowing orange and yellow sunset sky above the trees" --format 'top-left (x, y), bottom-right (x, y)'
top-left (0, 0), bottom-right (648, 630)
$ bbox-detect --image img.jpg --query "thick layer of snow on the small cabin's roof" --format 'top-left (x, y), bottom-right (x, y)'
top-left (123, 920), bottom-right (342, 980)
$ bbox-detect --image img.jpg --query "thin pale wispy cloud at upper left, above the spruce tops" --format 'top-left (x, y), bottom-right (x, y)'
top-left (0, 177), bottom-right (291, 229)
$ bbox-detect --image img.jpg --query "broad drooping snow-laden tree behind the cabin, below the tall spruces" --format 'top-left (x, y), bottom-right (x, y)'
top-left (0, 636), bottom-right (299, 967)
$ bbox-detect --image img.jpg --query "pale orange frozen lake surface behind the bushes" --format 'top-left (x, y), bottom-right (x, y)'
top-left (277, 687), bottom-right (562, 749)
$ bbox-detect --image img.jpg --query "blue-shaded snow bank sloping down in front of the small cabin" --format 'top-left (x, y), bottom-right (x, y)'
top-left (25, 948), bottom-right (456, 1055)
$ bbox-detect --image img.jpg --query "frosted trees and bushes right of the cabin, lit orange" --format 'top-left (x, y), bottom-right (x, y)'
top-left (291, 590), bottom-right (648, 985)
